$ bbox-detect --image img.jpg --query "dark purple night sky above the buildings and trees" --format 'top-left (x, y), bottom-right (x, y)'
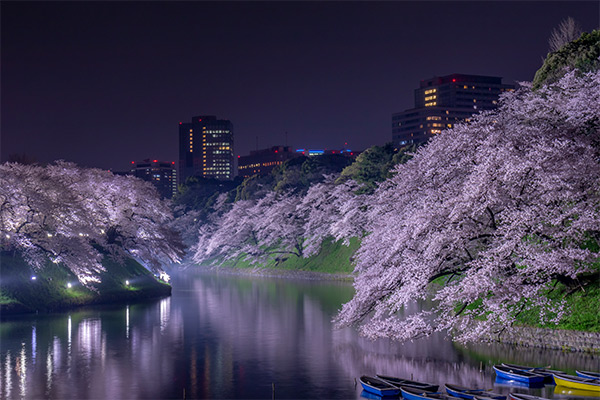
top-left (0, 0), bottom-right (600, 170)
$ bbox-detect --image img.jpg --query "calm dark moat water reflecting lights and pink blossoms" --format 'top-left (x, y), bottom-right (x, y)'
top-left (0, 272), bottom-right (600, 399)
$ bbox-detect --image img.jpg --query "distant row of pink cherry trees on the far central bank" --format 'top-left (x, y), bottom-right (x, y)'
top-left (194, 175), bottom-right (365, 264)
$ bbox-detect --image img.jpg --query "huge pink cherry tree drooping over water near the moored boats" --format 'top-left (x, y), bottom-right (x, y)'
top-left (336, 72), bottom-right (600, 342)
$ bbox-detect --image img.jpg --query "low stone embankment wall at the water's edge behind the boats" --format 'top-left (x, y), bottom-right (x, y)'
top-left (494, 327), bottom-right (600, 354)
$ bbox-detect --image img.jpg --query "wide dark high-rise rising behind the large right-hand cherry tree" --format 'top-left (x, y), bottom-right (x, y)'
top-left (392, 74), bottom-right (514, 146)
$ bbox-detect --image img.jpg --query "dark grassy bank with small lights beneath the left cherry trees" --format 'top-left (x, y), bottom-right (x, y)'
top-left (0, 253), bottom-right (171, 314)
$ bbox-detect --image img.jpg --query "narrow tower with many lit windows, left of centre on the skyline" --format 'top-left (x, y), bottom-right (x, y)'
top-left (179, 115), bottom-right (234, 182)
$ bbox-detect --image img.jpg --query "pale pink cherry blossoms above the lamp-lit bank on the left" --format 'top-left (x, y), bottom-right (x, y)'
top-left (0, 162), bottom-right (182, 284)
